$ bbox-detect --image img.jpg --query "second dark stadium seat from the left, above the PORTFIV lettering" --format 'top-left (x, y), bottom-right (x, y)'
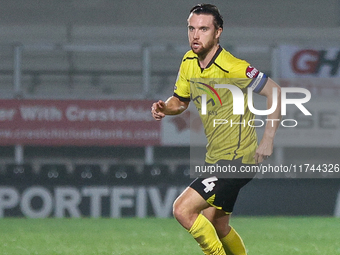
top-left (37, 164), bottom-right (70, 185)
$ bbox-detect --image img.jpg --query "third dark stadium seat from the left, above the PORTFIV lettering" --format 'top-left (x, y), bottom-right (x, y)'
top-left (72, 164), bottom-right (104, 185)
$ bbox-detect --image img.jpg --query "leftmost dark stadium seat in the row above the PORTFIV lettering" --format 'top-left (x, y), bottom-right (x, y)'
top-left (5, 164), bottom-right (35, 185)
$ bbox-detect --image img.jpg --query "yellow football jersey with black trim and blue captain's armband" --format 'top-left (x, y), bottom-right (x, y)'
top-left (174, 47), bottom-right (267, 164)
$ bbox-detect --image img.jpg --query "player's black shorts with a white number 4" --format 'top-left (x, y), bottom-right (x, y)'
top-left (190, 160), bottom-right (255, 214)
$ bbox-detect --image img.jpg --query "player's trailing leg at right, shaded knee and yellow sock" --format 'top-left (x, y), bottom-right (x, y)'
top-left (203, 207), bottom-right (247, 255)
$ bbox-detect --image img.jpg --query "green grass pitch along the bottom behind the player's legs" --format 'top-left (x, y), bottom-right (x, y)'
top-left (0, 216), bottom-right (340, 255)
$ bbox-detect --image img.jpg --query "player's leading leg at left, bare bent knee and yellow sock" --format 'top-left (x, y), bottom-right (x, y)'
top-left (173, 187), bottom-right (226, 255)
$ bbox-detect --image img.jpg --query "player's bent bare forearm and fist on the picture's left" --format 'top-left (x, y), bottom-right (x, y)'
top-left (151, 96), bottom-right (189, 120)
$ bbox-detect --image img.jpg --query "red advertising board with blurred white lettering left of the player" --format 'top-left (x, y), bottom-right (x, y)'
top-left (0, 99), bottom-right (161, 146)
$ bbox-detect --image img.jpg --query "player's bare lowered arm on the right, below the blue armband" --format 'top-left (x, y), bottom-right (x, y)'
top-left (254, 78), bottom-right (281, 163)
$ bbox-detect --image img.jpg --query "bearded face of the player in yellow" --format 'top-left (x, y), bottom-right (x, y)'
top-left (188, 14), bottom-right (222, 56)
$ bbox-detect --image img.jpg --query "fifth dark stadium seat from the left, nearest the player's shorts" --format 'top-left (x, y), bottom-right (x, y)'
top-left (143, 164), bottom-right (171, 185)
